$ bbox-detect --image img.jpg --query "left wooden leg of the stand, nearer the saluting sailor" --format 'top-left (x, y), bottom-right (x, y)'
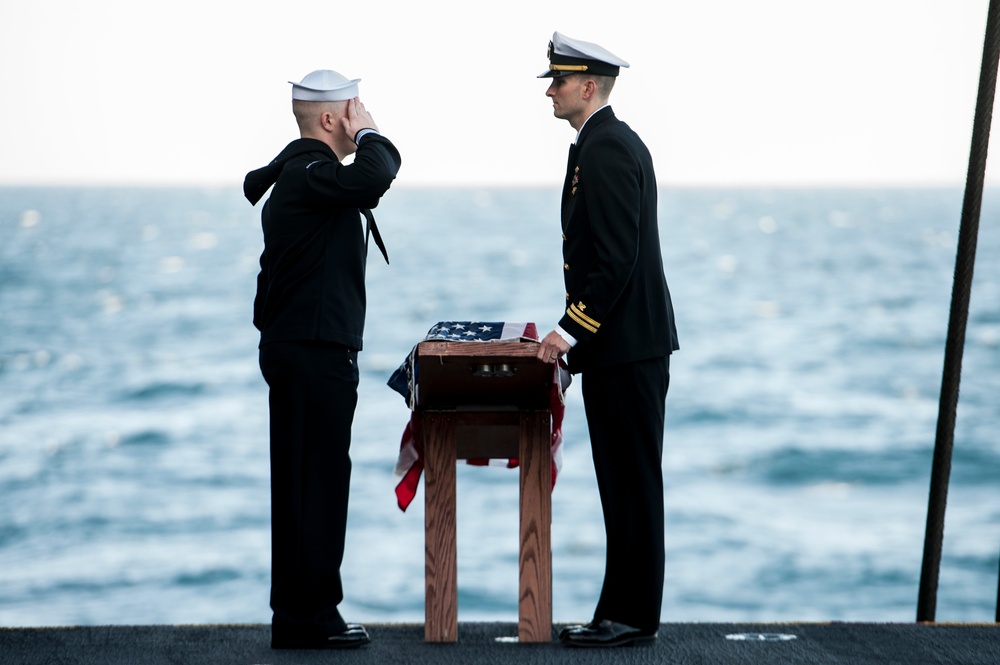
top-left (422, 413), bottom-right (458, 642)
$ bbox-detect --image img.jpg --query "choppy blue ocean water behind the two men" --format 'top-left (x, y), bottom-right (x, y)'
top-left (0, 187), bottom-right (1000, 626)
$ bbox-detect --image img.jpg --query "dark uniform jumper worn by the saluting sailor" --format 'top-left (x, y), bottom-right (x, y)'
top-left (244, 134), bottom-right (400, 350)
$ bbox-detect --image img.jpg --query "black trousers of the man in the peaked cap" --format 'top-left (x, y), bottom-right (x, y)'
top-left (581, 356), bottom-right (670, 632)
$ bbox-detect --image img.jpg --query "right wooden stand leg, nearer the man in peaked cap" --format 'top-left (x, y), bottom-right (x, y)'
top-left (517, 411), bottom-right (552, 642)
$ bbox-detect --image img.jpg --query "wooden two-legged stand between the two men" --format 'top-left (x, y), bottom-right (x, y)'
top-left (415, 342), bottom-right (552, 642)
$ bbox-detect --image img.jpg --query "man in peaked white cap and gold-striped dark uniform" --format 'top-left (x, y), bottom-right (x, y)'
top-left (538, 32), bottom-right (679, 647)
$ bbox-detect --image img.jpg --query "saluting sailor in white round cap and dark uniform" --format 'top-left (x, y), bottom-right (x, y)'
top-left (243, 70), bottom-right (400, 649)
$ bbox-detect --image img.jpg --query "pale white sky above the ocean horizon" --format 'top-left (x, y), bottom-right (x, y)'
top-left (0, 0), bottom-right (1000, 186)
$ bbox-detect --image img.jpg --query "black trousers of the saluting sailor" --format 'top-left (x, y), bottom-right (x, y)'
top-left (260, 341), bottom-right (358, 634)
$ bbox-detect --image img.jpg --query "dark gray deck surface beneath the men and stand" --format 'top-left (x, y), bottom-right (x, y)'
top-left (0, 623), bottom-right (1000, 665)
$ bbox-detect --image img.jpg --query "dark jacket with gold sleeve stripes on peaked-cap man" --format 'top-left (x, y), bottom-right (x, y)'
top-left (559, 106), bottom-right (679, 373)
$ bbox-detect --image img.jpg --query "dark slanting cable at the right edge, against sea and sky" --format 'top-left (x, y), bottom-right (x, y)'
top-left (917, 0), bottom-right (1000, 621)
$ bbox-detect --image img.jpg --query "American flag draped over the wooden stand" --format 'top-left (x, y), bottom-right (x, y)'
top-left (387, 321), bottom-right (569, 511)
